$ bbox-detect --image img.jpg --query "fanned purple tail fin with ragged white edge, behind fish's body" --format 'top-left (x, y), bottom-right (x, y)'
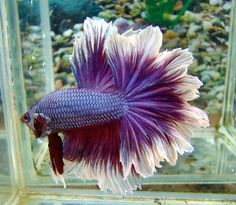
top-left (106, 26), bottom-right (209, 181)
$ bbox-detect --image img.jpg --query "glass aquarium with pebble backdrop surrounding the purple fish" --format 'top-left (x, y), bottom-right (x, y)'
top-left (0, 0), bottom-right (236, 205)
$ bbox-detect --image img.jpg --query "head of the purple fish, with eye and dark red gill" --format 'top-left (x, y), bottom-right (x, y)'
top-left (20, 104), bottom-right (51, 138)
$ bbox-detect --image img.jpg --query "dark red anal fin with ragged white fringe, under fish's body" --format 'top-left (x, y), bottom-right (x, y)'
top-left (63, 121), bottom-right (141, 194)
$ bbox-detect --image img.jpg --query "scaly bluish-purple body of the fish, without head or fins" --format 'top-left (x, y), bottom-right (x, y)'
top-left (38, 88), bottom-right (127, 131)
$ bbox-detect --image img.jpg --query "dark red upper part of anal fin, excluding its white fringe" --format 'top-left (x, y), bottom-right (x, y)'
top-left (63, 121), bottom-right (120, 171)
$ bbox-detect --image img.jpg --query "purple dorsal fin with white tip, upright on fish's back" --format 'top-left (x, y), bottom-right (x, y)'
top-left (70, 18), bottom-right (117, 91)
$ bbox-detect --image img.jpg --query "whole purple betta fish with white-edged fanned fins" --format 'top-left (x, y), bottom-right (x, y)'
top-left (21, 18), bottom-right (209, 194)
